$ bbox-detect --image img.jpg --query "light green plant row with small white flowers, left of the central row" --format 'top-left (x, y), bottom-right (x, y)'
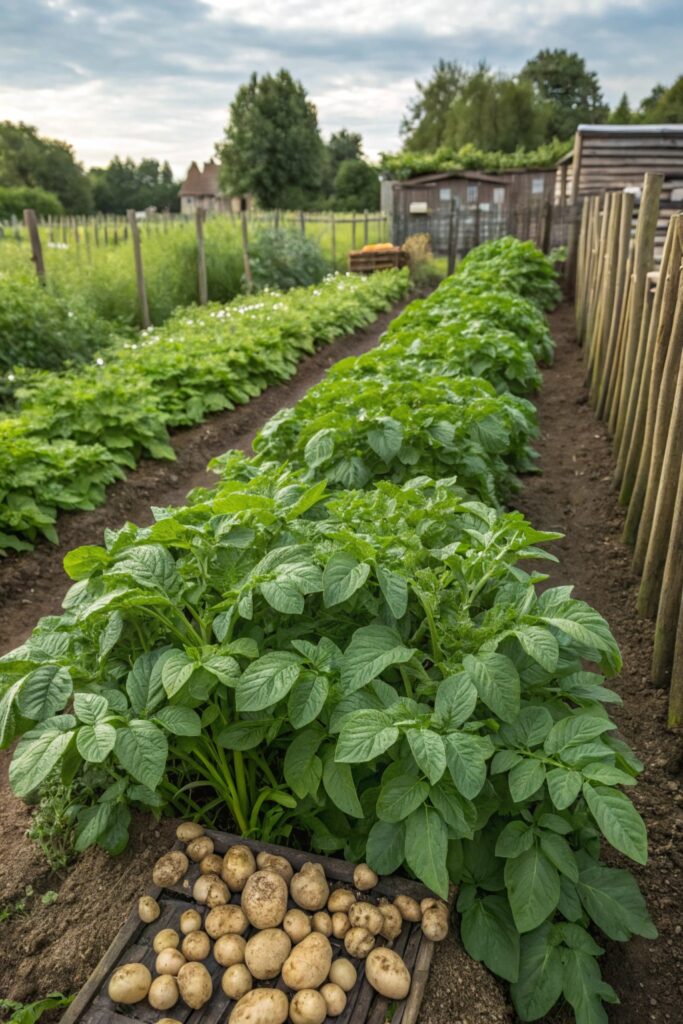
top-left (0, 270), bottom-right (409, 555)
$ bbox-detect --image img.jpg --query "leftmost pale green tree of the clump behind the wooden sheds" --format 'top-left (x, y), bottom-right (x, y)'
top-left (400, 60), bottom-right (470, 152)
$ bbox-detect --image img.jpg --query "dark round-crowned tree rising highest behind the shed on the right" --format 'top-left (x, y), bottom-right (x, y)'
top-left (521, 49), bottom-right (609, 138)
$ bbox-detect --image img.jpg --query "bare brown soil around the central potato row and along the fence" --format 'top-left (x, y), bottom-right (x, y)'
top-left (0, 306), bottom-right (683, 1024)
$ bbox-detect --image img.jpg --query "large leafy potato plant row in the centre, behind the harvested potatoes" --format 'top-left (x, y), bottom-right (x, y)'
top-left (0, 235), bottom-right (656, 1024)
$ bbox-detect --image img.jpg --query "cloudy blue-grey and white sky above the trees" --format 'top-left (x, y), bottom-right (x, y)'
top-left (0, 0), bottom-right (683, 173)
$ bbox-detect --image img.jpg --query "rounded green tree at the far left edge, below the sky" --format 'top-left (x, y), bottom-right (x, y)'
top-left (0, 121), bottom-right (92, 213)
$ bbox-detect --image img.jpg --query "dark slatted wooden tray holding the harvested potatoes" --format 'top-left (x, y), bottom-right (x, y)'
top-left (60, 830), bottom-right (434, 1024)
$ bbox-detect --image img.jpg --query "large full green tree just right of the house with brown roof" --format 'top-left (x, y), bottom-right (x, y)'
top-left (216, 69), bottom-right (324, 209)
